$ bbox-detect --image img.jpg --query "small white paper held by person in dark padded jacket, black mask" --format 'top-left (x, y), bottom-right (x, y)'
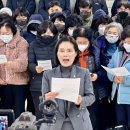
top-left (37, 60), bottom-right (52, 70)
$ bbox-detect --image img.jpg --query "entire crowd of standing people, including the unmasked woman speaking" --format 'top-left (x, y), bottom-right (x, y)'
top-left (0, 0), bottom-right (130, 130)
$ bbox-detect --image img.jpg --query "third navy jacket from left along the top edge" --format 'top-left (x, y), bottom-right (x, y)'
top-left (74, 0), bottom-right (108, 15)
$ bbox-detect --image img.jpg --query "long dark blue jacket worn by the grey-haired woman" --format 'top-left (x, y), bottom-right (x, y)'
top-left (93, 36), bottom-right (118, 99)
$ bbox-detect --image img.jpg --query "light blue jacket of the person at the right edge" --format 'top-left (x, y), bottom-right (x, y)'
top-left (107, 49), bottom-right (130, 104)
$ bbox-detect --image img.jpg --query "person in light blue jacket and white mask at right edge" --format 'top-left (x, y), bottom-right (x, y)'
top-left (108, 26), bottom-right (130, 129)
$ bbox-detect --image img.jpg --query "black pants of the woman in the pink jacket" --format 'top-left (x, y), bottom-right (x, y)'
top-left (0, 84), bottom-right (26, 118)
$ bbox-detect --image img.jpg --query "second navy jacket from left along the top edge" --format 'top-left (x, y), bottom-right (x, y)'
top-left (38, 0), bottom-right (71, 19)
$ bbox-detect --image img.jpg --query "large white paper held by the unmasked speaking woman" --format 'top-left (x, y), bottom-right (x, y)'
top-left (51, 78), bottom-right (80, 102)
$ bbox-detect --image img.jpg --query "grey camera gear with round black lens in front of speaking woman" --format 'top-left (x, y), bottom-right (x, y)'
top-left (8, 99), bottom-right (58, 130)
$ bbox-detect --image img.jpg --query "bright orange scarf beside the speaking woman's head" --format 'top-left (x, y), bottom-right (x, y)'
top-left (79, 49), bottom-right (89, 68)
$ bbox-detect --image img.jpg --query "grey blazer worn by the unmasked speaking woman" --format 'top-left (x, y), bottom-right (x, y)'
top-left (41, 65), bottom-right (95, 130)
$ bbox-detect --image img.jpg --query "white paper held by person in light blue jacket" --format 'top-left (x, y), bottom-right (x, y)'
top-left (101, 65), bottom-right (130, 76)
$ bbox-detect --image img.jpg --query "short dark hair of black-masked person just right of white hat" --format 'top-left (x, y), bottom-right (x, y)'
top-left (13, 7), bottom-right (30, 21)
